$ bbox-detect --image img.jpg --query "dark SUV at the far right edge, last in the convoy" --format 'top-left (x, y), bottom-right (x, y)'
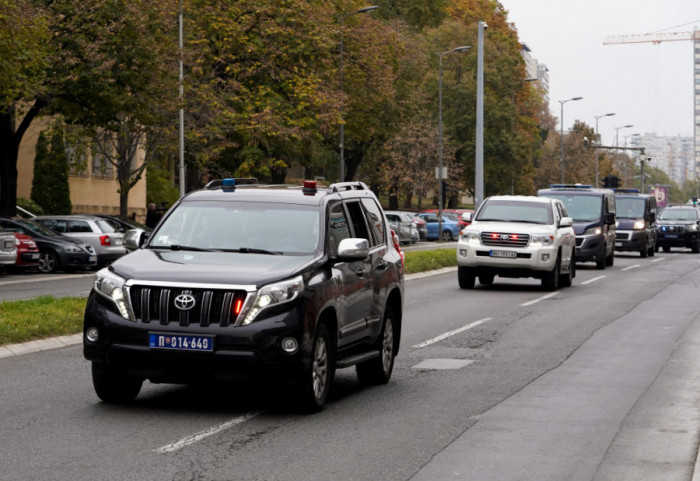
top-left (657, 205), bottom-right (700, 254)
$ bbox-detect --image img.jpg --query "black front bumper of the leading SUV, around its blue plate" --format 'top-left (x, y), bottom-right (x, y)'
top-left (83, 292), bottom-right (312, 383)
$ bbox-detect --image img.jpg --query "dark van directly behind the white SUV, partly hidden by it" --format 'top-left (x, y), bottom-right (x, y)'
top-left (537, 184), bottom-right (616, 269)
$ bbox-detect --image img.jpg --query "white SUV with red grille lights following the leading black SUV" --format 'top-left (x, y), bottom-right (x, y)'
top-left (457, 195), bottom-right (576, 291)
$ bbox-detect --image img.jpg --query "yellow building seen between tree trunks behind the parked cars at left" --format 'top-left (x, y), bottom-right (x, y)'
top-left (17, 118), bottom-right (146, 223)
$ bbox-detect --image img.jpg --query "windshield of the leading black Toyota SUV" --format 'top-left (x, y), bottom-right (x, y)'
top-left (149, 202), bottom-right (320, 255)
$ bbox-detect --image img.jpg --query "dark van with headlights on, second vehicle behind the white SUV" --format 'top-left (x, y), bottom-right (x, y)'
top-left (615, 189), bottom-right (657, 257)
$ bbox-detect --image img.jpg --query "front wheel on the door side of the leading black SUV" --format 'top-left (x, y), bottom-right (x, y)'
top-left (298, 324), bottom-right (335, 413)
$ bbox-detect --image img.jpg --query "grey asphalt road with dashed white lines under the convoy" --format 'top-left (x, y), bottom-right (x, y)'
top-left (0, 251), bottom-right (700, 481)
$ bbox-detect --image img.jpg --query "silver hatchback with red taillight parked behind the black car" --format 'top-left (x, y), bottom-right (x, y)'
top-left (32, 215), bottom-right (126, 266)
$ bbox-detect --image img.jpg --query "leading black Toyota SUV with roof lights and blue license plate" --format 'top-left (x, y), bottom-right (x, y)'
top-left (83, 179), bottom-right (404, 411)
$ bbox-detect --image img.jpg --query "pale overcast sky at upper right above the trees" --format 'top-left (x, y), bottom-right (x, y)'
top-left (500, 0), bottom-right (700, 145)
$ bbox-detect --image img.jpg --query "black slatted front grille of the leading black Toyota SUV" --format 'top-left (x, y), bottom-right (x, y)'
top-left (129, 285), bottom-right (247, 327)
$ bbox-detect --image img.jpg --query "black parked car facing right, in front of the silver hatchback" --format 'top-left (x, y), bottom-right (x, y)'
top-left (0, 217), bottom-right (97, 274)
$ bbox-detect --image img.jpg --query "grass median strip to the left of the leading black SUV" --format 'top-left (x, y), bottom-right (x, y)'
top-left (0, 296), bottom-right (86, 345)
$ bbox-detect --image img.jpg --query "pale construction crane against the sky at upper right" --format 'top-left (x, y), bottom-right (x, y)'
top-left (603, 29), bottom-right (700, 179)
